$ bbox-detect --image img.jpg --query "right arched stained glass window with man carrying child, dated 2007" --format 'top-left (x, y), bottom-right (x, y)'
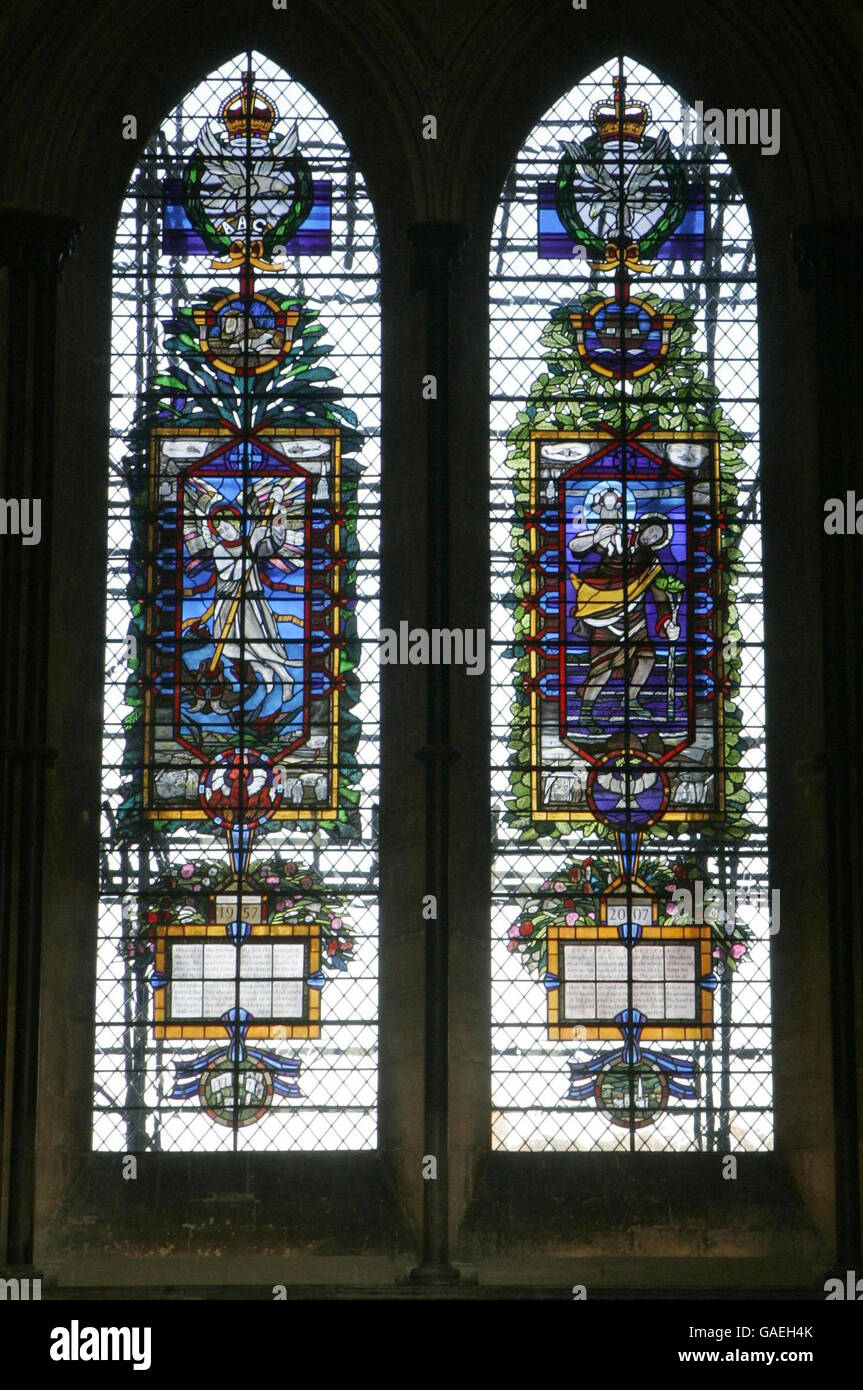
top-left (491, 57), bottom-right (778, 1152)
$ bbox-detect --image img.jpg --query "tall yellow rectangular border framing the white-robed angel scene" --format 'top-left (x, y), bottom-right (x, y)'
top-left (142, 425), bottom-right (342, 820)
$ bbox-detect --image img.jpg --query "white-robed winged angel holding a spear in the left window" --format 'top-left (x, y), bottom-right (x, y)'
top-left (183, 475), bottom-right (306, 710)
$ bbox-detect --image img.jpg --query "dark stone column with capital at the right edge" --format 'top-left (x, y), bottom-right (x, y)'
top-left (795, 220), bottom-right (863, 1270)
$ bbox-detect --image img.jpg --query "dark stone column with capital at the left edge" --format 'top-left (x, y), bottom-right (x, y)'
top-left (0, 202), bottom-right (78, 1269)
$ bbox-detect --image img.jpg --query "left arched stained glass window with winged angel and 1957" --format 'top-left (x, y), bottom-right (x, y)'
top-left (93, 53), bottom-right (379, 1151)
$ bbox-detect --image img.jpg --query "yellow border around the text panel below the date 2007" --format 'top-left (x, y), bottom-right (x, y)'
top-left (546, 923), bottom-right (713, 1043)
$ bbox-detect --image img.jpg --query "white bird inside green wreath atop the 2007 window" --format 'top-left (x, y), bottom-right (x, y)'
top-left (560, 131), bottom-right (671, 240)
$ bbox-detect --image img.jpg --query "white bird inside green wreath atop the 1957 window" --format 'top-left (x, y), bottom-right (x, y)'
top-left (197, 121), bottom-right (299, 238)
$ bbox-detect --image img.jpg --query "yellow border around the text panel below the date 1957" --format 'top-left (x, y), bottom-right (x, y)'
top-left (153, 922), bottom-right (321, 1041)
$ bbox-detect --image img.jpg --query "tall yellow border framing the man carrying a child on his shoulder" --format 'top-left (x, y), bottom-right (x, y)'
top-left (528, 430), bottom-right (725, 821)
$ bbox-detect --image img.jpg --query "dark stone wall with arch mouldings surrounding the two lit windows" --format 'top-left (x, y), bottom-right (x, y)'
top-left (0, 0), bottom-right (863, 1284)
